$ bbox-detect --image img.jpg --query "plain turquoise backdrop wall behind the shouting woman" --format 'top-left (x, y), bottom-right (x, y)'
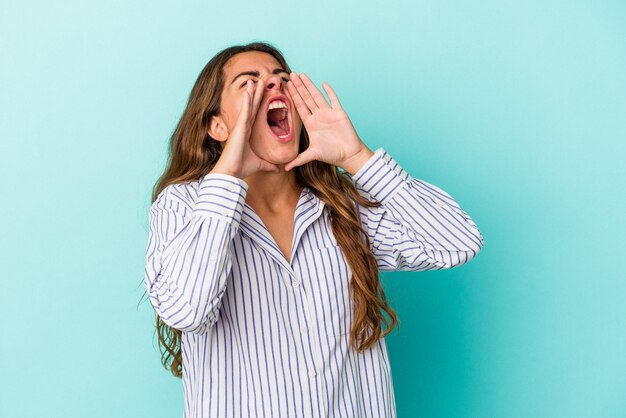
top-left (0, 0), bottom-right (626, 418)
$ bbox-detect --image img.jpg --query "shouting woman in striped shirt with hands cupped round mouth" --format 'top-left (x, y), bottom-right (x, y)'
top-left (145, 42), bottom-right (483, 418)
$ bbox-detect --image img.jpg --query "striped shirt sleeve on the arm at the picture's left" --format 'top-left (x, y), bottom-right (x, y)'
top-left (144, 173), bottom-right (248, 334)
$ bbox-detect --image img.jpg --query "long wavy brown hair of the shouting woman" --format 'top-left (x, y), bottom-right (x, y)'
top-left (143, 42), bottom-right (399, 377)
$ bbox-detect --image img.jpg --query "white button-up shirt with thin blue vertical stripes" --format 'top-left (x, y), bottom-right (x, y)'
top-left (145, 148), bottom-right (483, 418)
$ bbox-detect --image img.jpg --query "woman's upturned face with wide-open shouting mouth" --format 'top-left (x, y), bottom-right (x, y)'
top-left (209, 51), bottom-right (302, 164)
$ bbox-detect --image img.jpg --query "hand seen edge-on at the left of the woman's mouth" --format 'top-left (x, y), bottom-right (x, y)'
top-left (210, 79), bottom-right (279, 179)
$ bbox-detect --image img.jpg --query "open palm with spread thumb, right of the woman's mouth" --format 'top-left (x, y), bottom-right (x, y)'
top-left (285, 72), bottom-right (373, 174)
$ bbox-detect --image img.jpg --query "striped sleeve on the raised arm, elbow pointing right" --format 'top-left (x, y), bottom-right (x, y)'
top-left (352, 148), bottom-right (484, 271)
